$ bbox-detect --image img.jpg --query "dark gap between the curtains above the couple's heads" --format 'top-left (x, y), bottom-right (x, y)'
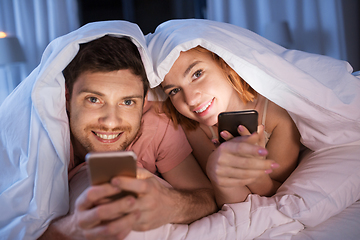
top-left (79, 0), bottom-right (206, 35)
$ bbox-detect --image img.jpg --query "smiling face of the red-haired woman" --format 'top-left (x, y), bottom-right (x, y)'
top-left (161, 49), bottom-right (241, 126)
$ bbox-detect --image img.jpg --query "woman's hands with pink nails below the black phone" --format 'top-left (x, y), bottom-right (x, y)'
top-left (206, 130), bottom-right (278, 187)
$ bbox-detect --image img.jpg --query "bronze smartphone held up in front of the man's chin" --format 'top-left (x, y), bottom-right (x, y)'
top-left (85, 151), bottom-right (137, 200)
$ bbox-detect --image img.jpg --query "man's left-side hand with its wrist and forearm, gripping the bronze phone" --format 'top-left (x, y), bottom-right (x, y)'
top-left (39, 181), bottom-right (140, 240)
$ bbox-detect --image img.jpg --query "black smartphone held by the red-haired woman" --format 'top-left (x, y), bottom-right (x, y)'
top-left (218, 110), bottom-right (258, 143)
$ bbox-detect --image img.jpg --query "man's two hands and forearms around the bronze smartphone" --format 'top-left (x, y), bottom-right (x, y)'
top-left (41, 168), bottom-right (215, 239)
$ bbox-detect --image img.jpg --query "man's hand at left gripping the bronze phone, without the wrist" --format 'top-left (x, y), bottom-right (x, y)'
top-left (74, 184), bottom-right (140, 239)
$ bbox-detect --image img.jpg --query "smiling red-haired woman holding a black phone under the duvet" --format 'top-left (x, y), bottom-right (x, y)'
top-left (146, 21), bottom-right (300, 206)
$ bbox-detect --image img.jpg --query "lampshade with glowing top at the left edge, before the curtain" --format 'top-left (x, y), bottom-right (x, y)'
top-left (0, 32), bottom-right (25, 65)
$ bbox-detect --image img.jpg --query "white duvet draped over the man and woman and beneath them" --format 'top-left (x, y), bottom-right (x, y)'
top-left (0, 20), bottom-right (360, 240)
